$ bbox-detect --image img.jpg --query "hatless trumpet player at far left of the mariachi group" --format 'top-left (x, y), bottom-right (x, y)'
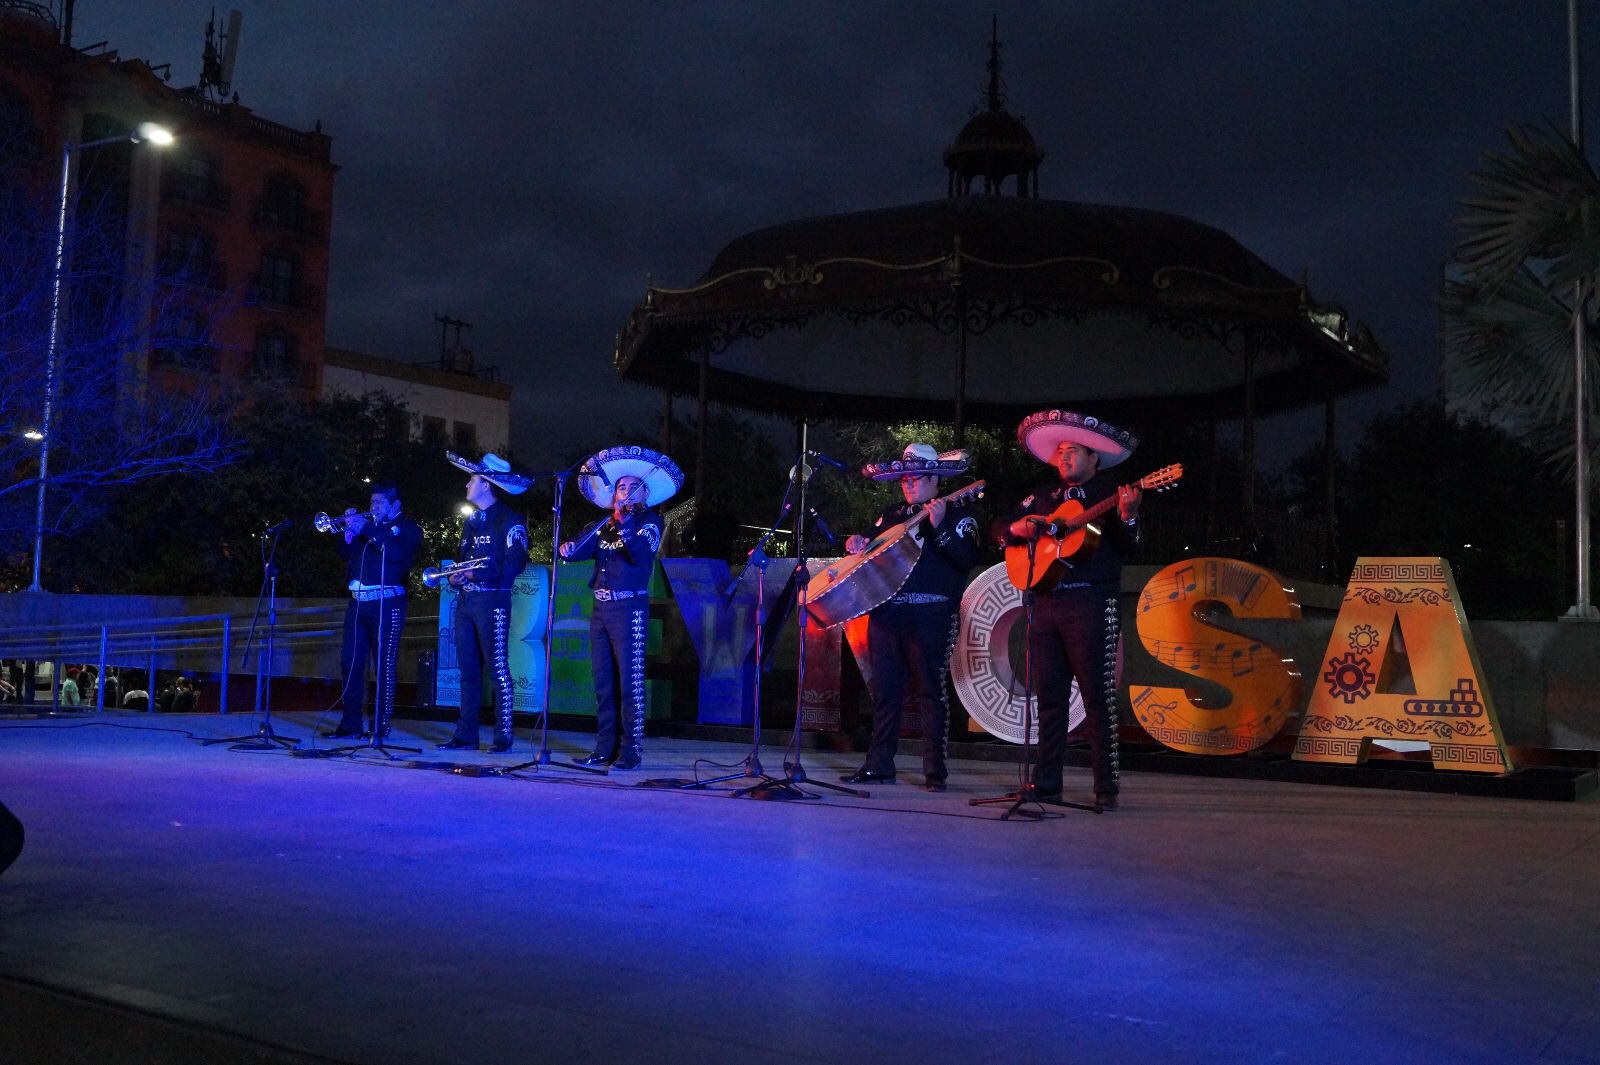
top-left (326, 481), bottom-right (422, 739)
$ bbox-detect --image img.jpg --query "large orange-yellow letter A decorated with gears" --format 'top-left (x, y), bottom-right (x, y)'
top-left (1294, 558), bottom-right (1512, 774)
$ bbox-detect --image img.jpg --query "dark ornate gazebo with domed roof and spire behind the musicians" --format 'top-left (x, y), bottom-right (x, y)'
top-left (614, 24), bottom-right (1387, 559)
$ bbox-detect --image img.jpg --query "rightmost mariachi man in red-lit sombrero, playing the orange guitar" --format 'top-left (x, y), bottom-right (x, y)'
top-left (998, 411), bottom-right (1142, 812)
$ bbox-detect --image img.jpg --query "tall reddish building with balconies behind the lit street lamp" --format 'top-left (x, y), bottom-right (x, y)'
top-left (0, 2), bottom-right (338, 397)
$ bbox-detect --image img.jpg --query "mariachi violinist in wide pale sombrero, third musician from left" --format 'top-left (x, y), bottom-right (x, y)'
top-left (560, 446), bottom-right (683, 769)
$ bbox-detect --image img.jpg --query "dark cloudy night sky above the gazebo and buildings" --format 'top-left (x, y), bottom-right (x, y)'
top-left (74, 0), bottom-right (1600, 464)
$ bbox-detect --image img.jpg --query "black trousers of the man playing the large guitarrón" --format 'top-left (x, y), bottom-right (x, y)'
top-left (867, 600), bottom-right (960, 780)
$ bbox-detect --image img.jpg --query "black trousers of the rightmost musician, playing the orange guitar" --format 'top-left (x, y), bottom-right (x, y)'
top-left (1029, 584), bottom-right (1122, 795)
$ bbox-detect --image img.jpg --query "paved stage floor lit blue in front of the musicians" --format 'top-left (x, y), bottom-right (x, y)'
top-left (0, 703), bottom-right (1600, 1065)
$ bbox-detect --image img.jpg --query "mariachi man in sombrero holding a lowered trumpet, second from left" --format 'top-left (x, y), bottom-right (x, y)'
top-left (438, 451), bottom-right (533, 752)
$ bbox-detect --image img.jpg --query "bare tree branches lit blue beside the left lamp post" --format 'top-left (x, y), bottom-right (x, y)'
top-left (0, 140), bottom-right (240, 582)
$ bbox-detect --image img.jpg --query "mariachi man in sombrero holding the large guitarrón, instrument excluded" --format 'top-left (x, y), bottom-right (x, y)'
top-left (842, 443), bottom-right (979, 792)
